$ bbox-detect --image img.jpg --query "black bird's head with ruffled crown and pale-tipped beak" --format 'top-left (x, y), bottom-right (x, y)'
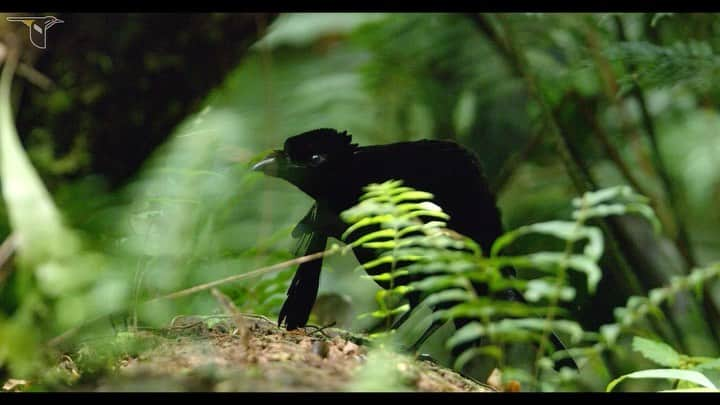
top-left (252, 128), bottom-right (357, 196)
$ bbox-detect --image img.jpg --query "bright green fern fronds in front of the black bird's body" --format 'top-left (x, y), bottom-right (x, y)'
top-left (341, 180), bottom-right (668, 391)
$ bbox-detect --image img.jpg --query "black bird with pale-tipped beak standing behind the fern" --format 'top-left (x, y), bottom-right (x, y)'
top-left (252, 128), bottom-right (572, 366)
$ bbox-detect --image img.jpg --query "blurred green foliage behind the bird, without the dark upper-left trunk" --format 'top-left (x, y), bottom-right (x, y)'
top-left (0, 13), bottom-right (720, 390)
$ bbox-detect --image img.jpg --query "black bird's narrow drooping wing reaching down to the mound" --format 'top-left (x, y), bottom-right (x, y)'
top-left (278, 205), bottom-right (327, 330)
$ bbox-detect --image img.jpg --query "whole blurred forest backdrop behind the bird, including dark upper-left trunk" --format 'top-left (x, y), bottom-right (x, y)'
top-left (0, 13), bottom-right (720, 389)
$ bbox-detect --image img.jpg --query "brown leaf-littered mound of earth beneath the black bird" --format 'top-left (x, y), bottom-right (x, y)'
top-left (12, 314), bottom-right (495, 392)
